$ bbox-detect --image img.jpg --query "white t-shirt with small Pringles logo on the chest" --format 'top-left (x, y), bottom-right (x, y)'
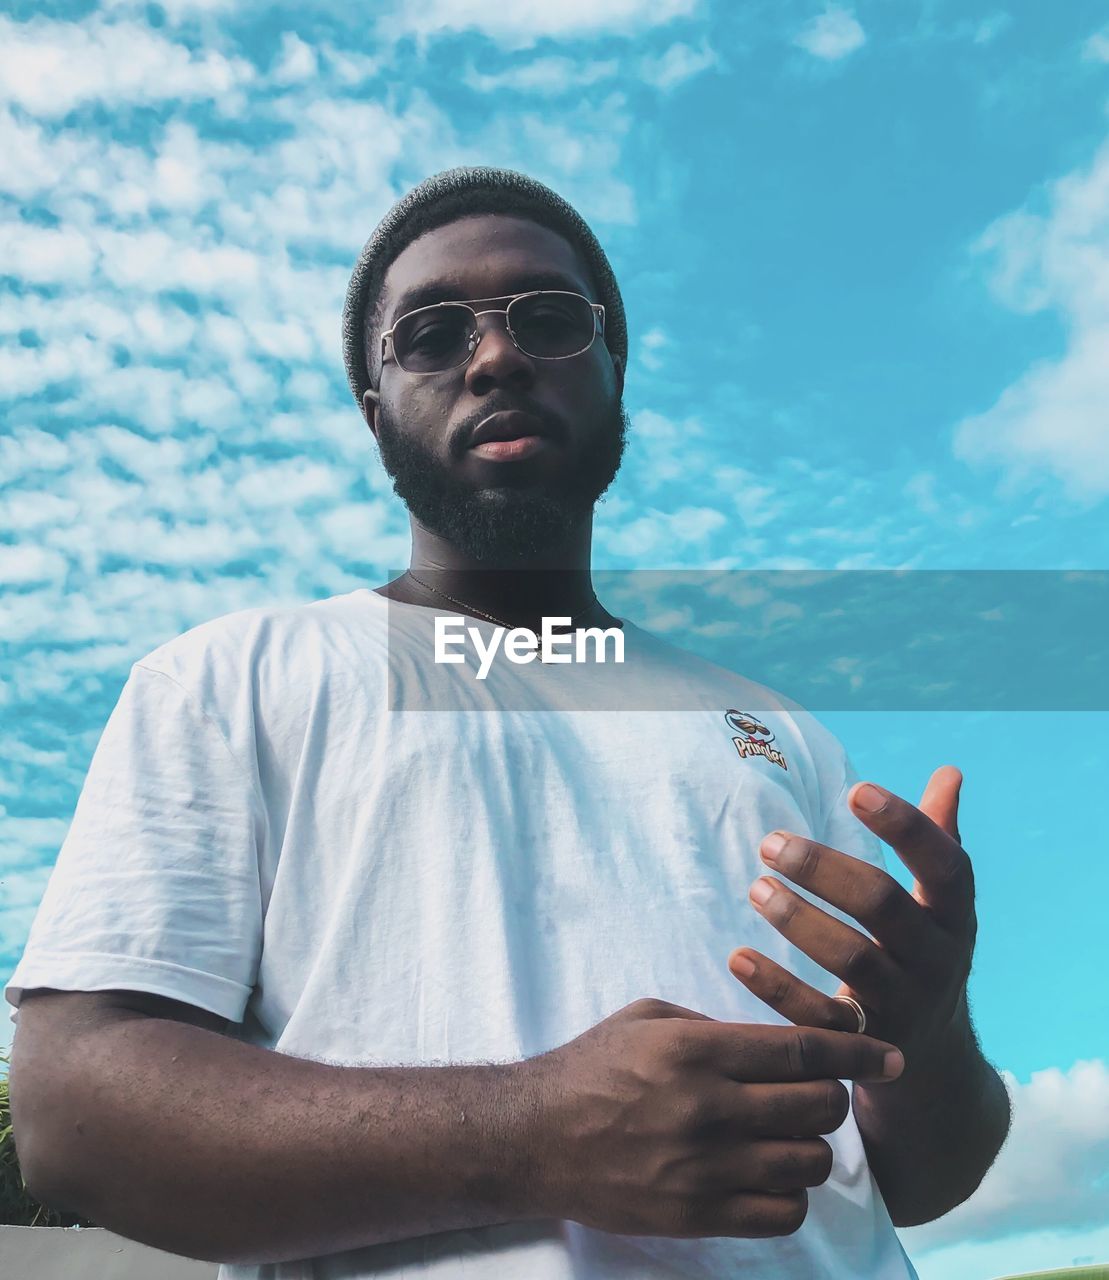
top-left (5, 589), bottom-right (916, 1280)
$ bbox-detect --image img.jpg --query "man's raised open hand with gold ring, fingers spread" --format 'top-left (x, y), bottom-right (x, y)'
top-left (729, 764), bottom-right (978, 1074)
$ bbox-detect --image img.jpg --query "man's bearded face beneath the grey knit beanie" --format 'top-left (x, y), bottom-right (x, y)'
top-left (365, 214), bottom-right (627, 564)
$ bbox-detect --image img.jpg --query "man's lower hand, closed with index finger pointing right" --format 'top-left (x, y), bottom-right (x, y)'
top-left (524, 998), bottom-right (904, 1238)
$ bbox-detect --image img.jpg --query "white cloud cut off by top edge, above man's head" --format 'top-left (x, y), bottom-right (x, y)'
top-left (378, 0), bottom-right (699, 49)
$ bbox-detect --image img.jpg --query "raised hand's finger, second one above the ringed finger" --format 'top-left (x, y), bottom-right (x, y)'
top-left (759, 831), bottom-right (948, 966)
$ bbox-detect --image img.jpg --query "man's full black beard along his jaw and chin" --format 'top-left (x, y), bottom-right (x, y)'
top-left (378, 399), bottom-right (629, 567)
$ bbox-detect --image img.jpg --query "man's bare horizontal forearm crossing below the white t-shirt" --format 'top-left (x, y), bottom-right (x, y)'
top-left (17, 1016), bottom-right (542, 1263)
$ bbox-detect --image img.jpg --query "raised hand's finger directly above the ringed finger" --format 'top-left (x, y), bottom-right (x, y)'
top-left (750, 876), bottom-right (904, 1009)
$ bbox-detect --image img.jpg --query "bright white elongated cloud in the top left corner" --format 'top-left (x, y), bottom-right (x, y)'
top-left (0, 17), bottom-right (255, 119)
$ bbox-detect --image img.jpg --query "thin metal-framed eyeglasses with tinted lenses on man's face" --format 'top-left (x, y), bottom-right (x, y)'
top-left (382, 289), bottom-right (604, 374)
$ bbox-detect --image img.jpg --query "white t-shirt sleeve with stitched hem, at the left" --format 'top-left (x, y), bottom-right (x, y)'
top-left (4, 663), bottom-right (264, 1023)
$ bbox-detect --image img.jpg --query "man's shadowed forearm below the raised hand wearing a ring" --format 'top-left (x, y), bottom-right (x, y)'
top-left (852, 1006), bottom-right (1010, 1226)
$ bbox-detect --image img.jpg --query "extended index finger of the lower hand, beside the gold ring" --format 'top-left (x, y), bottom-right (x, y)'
top-left (684, 1021), bottom-right (905, 1084)
